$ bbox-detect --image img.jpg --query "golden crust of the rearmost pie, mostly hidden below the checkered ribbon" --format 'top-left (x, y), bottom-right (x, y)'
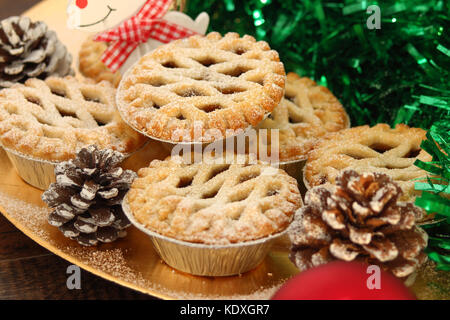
top-left (78, 36), bottom-right (122, 87)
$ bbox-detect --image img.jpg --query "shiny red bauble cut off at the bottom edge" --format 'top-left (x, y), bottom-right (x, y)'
top-left (272, 261), bottom-right (416, 300)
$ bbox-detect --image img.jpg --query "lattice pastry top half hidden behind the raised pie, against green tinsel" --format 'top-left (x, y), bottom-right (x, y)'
top-left (258, 72), bottom-right (350, 162)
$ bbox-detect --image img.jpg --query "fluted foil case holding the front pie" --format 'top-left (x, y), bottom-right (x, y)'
top-left (122, 196), bottom-right (287, 276)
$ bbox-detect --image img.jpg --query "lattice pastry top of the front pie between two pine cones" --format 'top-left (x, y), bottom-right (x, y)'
top-left (126, 157), bottom-right (302, 244)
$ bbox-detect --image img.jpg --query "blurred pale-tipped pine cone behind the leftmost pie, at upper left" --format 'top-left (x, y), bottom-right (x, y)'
top-left (0, 17), bottom-right (73, 88)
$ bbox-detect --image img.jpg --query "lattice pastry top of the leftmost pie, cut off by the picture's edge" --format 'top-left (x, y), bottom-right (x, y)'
top-left (0, 77), bottom-right (146, 161)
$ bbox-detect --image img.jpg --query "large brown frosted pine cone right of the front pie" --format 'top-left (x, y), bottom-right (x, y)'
top-left (289, 170), bottom-right (427, 278)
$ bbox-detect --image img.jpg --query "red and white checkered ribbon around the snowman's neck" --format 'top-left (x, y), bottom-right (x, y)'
top-left (94, 0), bottom-right (197, 72)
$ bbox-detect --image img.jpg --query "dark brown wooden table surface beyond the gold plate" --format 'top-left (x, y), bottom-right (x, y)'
top-left (0, 0), bottom-right (152, 300)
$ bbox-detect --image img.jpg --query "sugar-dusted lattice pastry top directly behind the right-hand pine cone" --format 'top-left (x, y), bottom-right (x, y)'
top-left (304, 124), bottom-right (431, 200)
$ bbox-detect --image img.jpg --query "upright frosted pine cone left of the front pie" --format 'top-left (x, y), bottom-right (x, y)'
top-left (42, 146), bottom-right (136, 246)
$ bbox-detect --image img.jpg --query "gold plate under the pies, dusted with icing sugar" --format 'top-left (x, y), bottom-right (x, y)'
top-left (0, 0), bottom-right (450, 299)
